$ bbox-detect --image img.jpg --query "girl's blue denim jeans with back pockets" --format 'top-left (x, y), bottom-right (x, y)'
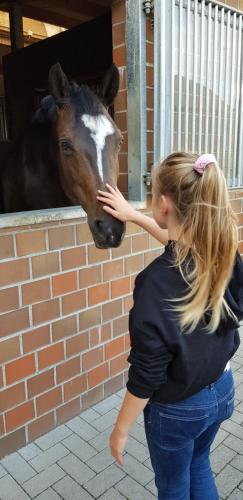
top-left (144, 370), bottom-right (234, 500)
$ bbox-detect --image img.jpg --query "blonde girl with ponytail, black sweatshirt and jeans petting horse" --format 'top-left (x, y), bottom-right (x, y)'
top-left (98, 153), bottom-right (243, 500)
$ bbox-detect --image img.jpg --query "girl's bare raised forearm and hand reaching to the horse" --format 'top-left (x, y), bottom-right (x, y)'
top-left (97, 184), bottom-right (168, 245)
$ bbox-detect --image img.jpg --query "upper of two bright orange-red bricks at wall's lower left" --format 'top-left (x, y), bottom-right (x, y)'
top-left (5, 354), bottom-right (35, 384)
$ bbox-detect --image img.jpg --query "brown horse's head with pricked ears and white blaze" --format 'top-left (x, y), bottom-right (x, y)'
top-left (49, 63), bottom-right (125, 248)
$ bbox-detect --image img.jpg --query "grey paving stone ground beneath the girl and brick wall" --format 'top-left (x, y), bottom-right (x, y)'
top-left (0, 328), bottom-right (243, 500)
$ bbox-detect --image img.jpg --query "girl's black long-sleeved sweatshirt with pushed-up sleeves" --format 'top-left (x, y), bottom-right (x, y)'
top-left (127, 241), bottom-right (243, 403)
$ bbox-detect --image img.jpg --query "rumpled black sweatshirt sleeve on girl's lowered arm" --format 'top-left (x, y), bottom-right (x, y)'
top-left (127, 270), bottom-right (173, 398)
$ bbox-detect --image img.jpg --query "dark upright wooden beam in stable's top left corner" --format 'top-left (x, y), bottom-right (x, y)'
top-left (8, 2), bottom-right (24, 52)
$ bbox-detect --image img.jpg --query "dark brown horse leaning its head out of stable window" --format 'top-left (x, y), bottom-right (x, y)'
top-left (0, 63), bottom-right (125, 248)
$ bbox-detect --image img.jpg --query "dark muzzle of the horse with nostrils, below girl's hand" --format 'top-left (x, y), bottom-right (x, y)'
top-left (90, 217), bottom-right (125, 248)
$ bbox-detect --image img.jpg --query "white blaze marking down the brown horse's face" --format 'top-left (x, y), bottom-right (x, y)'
top-left (81, 114), bottom-right (115, 181)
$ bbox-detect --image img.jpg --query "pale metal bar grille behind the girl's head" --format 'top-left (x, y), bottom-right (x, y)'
top-left (154, 0), bottom-right (243, 187)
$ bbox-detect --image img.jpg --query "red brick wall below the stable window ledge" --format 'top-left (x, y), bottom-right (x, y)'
top-left (0, 215), bottom-right (163, 455)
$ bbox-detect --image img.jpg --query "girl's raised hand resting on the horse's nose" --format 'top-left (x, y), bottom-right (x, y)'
top-left (97, 184), bottom-right (136, 222)
